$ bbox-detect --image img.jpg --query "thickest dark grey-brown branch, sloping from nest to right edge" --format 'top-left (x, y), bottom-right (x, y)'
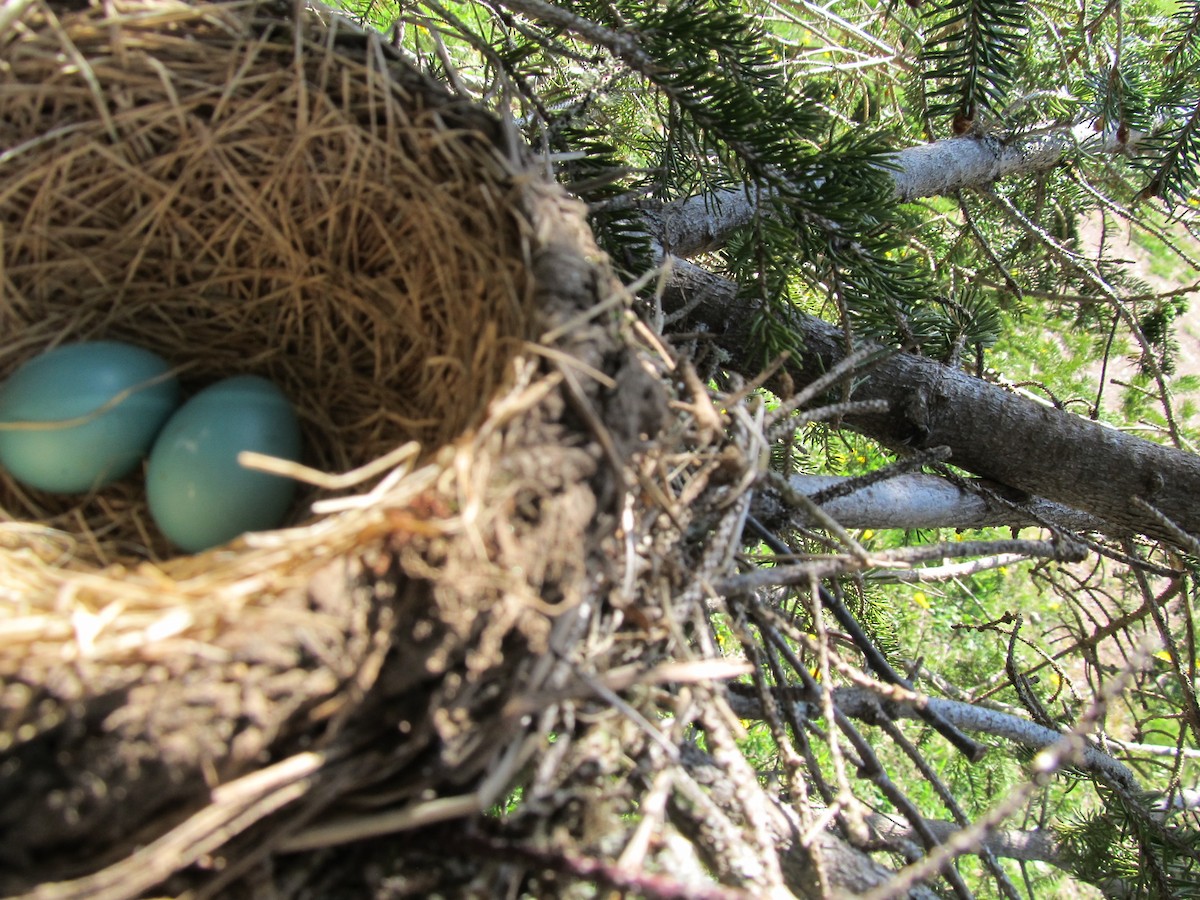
top-left (666, 263), bottom-right (1200, 544)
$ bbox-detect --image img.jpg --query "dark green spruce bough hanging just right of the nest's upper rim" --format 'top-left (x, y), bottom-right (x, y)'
top-left (535, 0), bottom-right (935, 361)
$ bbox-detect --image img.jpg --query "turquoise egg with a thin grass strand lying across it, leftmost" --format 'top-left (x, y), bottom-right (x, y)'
top-left (0, 341), bottom-right (179, 493)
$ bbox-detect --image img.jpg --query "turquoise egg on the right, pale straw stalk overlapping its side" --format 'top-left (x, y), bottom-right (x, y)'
top-left (146, 376), bottom-right (300, 553)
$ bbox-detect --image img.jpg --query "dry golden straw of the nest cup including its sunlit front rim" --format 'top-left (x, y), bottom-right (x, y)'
top-left (0, 0), bottom-right (577, 751)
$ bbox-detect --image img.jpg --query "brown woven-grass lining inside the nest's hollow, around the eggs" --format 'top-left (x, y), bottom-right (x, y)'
top-left (0, 2), bottom-right (534, 570)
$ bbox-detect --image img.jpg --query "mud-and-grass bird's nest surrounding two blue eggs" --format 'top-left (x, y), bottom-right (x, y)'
top-left (0, 0), bottom-right (700, 898)
